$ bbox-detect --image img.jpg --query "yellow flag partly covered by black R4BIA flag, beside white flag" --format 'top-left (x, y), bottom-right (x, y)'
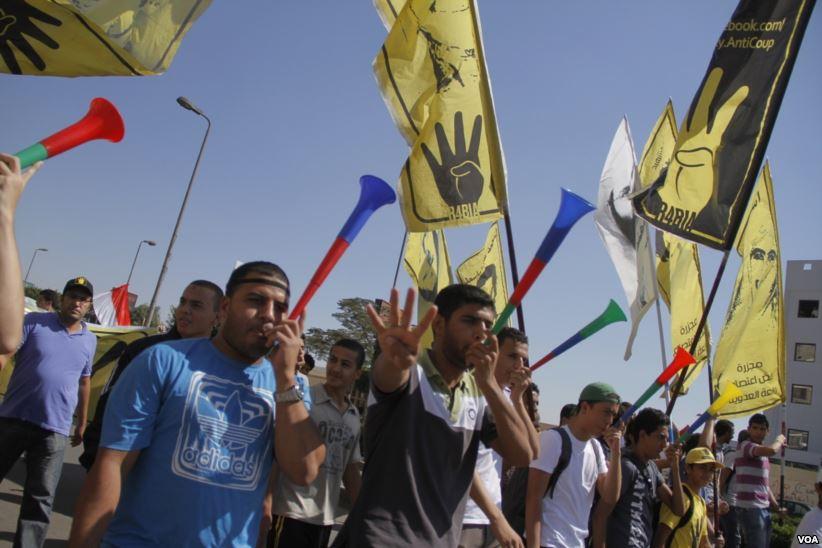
top-left (639, 101), bottom-right (710, 393)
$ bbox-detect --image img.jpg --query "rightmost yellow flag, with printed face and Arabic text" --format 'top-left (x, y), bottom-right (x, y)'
top-left (714, 162), bottom-right (785, 417)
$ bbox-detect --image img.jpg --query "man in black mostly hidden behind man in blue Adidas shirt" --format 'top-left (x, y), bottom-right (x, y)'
top-left (79, 280), bottom-right (223, 471)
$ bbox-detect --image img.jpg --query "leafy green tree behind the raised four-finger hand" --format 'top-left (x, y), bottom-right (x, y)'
top-left (305, 297), bottom-right (377, 368)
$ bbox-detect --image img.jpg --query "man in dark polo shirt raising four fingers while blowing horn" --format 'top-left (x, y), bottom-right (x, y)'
top-left (334, 284), bottom-right (532, 548)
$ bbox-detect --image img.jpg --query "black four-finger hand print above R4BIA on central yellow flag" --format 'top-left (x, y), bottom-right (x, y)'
top-left (422, 111), bottom-right (485, 207)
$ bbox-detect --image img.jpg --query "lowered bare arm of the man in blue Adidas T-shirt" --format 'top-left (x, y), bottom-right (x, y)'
top-left (68, 447), bottom-right (140, 548)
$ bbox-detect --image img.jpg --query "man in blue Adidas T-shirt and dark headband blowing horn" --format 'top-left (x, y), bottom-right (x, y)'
top-left (69, 261), bottom-right (325, 547)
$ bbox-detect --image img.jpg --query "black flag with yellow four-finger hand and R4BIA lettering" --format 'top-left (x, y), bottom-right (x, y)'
top-left (634, 0), bottom-right (815, 249)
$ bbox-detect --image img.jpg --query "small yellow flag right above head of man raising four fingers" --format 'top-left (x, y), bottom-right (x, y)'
top-left (457, 223), bottom-right (511, 318)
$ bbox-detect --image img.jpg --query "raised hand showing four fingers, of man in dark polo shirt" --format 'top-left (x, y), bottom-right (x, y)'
top-left (366, 289), bottom-right (437, 394)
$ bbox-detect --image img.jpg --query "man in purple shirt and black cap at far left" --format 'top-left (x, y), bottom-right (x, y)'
top-left (0, 277), bottom-right (97, 547)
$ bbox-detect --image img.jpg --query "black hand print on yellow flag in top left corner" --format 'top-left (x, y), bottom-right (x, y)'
top-left (0, 0), bottom-right (63, 74)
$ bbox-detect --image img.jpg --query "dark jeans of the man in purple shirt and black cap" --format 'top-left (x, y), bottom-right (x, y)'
top-left (0, 418), bottom-right (66, 548)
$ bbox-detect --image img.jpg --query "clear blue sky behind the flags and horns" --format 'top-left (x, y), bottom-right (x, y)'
top-left (0, 0), bottom-right (822, 423)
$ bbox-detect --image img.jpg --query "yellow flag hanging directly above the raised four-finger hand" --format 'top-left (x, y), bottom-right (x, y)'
top-left (404, 230), bottom-right (452, 348)
